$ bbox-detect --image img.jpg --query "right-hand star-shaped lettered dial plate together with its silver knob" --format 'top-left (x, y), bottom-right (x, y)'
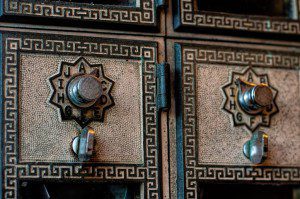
top-left (222, 67), bottom-right (278, 132)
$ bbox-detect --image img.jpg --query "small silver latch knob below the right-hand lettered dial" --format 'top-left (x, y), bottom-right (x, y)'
top-left (243, 131), bottom-right (268, 164)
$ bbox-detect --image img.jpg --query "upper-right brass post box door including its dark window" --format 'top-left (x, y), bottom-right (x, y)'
top-left (173, 0), bottom-right (300, 36)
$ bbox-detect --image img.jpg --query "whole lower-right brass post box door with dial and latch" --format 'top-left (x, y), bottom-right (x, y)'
top-left (168, 40), bottom-right (300, 198)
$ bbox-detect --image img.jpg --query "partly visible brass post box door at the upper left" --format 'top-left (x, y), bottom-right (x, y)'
top-left (0, 0), bottom-right (164, 31)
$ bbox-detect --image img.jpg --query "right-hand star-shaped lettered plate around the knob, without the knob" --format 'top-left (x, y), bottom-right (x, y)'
top-left (222, 67), bottom-right (278, 132)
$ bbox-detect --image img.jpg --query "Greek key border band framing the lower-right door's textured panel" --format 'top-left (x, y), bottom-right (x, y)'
top-left (181, 44), bottom-right (300, 198)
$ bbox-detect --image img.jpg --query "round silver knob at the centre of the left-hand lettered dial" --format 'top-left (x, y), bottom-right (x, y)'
top-left (67, 75), bottom-right (102, 108)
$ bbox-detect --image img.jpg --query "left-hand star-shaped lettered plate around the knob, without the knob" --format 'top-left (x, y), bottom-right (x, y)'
top-left (49, 57), bottom-right (114, 127)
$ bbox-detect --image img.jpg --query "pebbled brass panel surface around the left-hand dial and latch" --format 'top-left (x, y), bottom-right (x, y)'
top-left (19, 54), bottom-right (143, 164)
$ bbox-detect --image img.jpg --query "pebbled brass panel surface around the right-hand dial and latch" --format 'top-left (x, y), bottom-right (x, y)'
top-left (196, 64), bottom-right (300, 166)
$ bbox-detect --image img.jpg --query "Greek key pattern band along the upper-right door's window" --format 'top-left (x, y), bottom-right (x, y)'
top-left (178, 0), bottom-right (300, 34)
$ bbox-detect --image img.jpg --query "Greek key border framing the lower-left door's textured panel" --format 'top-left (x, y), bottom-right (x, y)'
top-left (3, 34), bottom-right (160, 198)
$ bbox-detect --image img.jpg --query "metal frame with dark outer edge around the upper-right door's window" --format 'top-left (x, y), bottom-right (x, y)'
top-left (173, 0), bottom-right (300, 35)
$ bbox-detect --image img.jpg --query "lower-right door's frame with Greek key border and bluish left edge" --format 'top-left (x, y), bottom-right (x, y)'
top-left (172, 40), bottom-right (300, 198)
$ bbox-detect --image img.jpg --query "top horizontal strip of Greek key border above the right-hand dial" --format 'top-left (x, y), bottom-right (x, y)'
top-left (183, 46), bottom-right (300, 68)
